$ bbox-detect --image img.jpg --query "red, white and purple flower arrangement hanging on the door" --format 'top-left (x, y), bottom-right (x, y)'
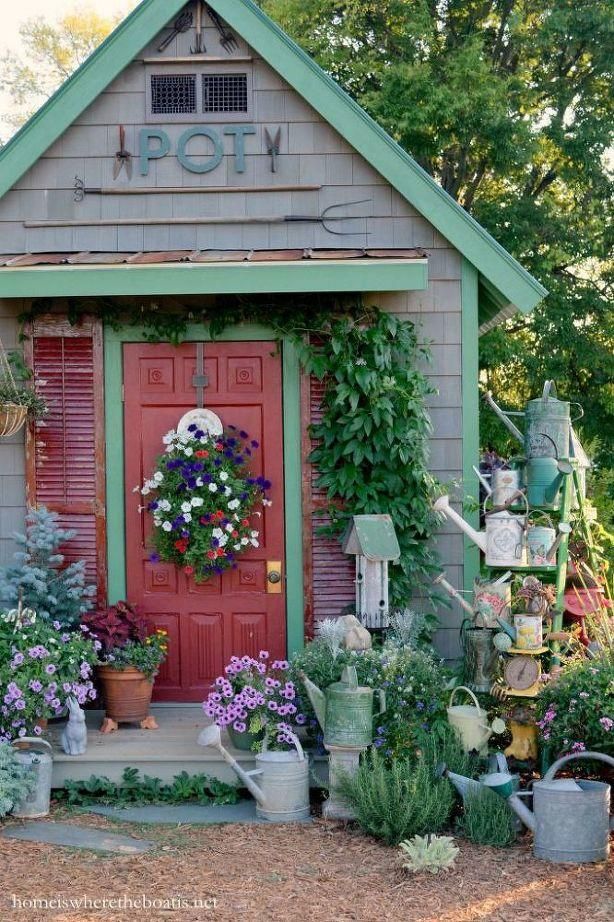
top-left (134, 424), bottom-right (271, 582)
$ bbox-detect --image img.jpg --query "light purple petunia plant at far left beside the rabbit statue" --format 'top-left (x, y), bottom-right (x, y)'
top-left (0, 607), bottom-right (99, 741)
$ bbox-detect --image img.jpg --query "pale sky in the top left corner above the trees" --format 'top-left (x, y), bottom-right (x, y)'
top-left (0, 0), bottom-right (136, 138)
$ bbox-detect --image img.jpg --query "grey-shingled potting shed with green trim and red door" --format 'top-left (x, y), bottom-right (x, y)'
top-left (0, 0), bottom-right (545, 702)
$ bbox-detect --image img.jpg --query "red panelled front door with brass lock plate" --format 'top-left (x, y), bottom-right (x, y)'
top-left (124, 342), bottom-right (286, 701)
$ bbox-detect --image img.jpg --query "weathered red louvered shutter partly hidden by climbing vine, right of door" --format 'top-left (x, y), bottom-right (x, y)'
top-left (309, 377), bottom-right (355, 621)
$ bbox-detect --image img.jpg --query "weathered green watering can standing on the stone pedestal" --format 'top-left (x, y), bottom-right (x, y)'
top-left (300, 666), bottom-right (386, 749)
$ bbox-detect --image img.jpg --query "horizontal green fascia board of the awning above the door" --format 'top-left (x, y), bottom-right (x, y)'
top-left (0, 259), bottom-right (428, 298)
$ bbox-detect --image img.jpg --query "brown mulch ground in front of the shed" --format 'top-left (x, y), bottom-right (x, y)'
top-left (0, 812), bottom-right (614, 922)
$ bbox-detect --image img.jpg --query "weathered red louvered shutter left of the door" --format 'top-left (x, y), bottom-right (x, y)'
top-left (26, 315), bottom-right (107, 604)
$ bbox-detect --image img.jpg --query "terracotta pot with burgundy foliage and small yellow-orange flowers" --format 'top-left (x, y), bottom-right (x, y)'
top-left (83, 602), bottom-right (168, 733)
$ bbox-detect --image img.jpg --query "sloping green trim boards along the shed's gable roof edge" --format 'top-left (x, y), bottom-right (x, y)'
top-left (0, 0), bottom-right (547, 332)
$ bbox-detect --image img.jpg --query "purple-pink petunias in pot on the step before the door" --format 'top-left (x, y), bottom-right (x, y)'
top-left (203, 650), bottom-right (306, 750)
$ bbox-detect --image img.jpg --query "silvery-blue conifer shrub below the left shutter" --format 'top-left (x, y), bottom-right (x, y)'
top-left (0, 506), bottom-right (96, 627)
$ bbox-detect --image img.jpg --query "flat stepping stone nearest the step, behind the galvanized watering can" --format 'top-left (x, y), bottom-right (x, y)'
top-left (82, 800), bottom-right (311, 826)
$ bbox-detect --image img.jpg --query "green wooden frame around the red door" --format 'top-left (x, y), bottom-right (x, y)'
top-left (104, 323), bottom-right (305, 656)
